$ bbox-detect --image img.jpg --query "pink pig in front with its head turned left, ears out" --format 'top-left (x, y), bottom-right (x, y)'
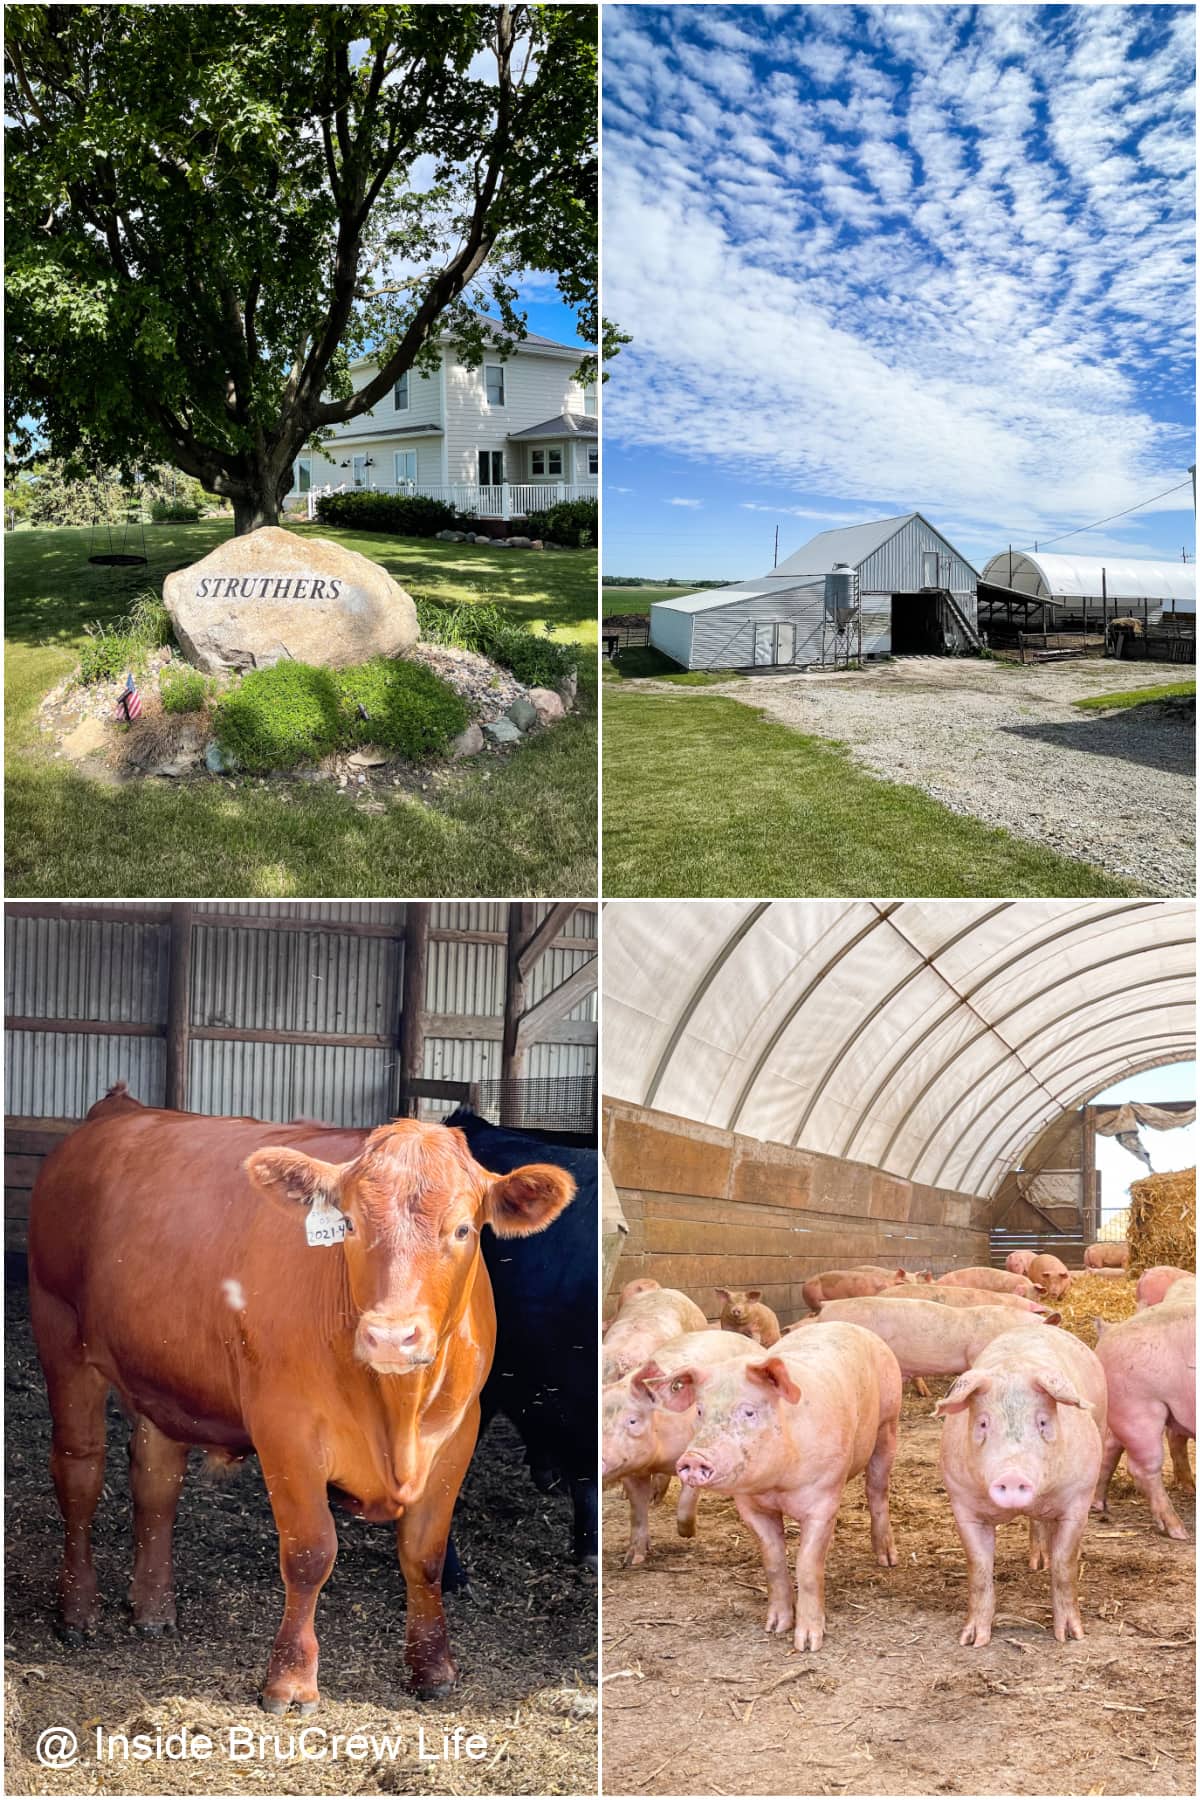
top-left (647, 1325), bottom-right (901, 1651)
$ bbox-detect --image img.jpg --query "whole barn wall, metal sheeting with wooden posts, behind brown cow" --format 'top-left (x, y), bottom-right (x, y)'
top-left (5, 900), bottom-right (597, 1249)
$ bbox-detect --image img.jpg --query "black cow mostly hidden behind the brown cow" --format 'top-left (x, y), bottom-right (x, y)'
top-left (443, 1107), bottom-right (599, 1589)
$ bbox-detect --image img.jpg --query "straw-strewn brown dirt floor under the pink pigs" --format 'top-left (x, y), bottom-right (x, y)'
top-left (603, 1382), bottom-right (1196, 1795)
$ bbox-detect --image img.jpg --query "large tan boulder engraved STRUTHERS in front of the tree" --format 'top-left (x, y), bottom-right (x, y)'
top-left (164, 526), bottom-right (419, 675)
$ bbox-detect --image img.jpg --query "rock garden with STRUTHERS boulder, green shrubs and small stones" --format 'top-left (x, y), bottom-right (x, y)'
top-left (38, 527), bottom-right (578, 801)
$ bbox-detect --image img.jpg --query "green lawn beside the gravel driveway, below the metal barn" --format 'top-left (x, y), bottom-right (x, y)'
top-left (604, 686), bottom-right (1135, 898)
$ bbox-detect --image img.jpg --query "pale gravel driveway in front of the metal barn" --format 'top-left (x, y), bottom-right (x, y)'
top-left (694, 657), bottom-right (1196, 895)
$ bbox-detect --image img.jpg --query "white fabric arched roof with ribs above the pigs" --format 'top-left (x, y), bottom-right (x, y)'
top-left (604, 900), bottom-right (1195, 1195)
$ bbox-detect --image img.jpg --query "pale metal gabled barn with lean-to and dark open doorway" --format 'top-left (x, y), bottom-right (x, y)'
top-left (649, 513), bottom-right (979, 670)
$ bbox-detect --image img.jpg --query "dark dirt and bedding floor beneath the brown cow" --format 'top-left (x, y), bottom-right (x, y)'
top-left (5, 1287), bottom-right (596, 1795)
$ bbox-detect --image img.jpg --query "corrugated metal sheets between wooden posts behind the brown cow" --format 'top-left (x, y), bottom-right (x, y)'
top-left (5, 902), bottom-right (597, 1125)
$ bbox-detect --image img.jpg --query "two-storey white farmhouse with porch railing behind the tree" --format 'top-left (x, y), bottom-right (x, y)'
top-left (291, 331), bottom-right (599, 518)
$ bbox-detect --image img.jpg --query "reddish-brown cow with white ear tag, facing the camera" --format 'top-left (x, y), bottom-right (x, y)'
top-left (29, 1096), bottom-right (574, 1714)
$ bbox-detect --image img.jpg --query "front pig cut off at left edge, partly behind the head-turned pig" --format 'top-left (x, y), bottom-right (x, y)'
top-left (601, 1330), bottom-right (756, 1568)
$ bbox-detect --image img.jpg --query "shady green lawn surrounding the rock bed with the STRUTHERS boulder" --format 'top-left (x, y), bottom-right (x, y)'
top-left (5, 520), bottom-right (596, 896)
